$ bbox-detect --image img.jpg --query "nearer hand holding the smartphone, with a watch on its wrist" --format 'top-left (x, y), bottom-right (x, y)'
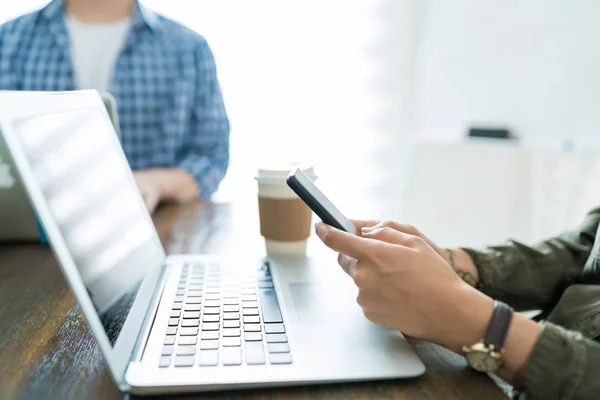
top-left (316, 223), bottom-right (492, 349)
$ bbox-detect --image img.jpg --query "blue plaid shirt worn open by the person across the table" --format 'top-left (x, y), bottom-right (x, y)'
top-left (0, 0), bottom-right (229, 199)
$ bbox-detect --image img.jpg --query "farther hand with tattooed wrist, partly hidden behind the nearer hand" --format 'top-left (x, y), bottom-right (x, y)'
top-left (352, 220), bottom-right (479, 286)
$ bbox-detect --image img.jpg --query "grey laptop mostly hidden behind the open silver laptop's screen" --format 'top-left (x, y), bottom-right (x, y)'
top-left (0, 91), bottom-right (119, 242)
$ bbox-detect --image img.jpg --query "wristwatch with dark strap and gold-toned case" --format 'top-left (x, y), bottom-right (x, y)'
top-left (463, 300), bottom-right (513, 372)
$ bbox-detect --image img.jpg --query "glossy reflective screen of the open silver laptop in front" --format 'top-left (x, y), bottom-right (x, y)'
top-left (13, 108), bottom-right (162, 346)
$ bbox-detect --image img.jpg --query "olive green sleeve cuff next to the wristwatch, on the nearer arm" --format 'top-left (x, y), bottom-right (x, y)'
top-left (524, 322), bottom-right (600, 400)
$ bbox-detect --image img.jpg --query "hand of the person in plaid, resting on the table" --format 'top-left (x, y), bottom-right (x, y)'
top-left (133, 168), bottom-right (200, 214)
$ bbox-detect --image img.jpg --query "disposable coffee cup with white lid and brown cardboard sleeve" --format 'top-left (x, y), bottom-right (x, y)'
top-left (256, 163), bottom-right (317, 256)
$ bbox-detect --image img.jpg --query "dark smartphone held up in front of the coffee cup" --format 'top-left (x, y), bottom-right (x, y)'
top-left (286, 168), bottom-right (356, 234)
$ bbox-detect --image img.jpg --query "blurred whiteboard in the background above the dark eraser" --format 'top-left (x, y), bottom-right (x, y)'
top-left (412, 0), bottom-right (600, 140)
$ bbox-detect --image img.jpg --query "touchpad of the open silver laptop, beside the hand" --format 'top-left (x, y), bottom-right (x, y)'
top-left (290, 283), bottom-right (362, 322)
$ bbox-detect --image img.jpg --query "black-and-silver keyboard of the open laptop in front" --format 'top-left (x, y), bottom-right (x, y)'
top-left (158, 263), bottom-right (292, 368)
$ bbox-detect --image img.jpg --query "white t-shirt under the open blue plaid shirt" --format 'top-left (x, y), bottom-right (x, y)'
top-left (65, 16), bottom-right (131, 92)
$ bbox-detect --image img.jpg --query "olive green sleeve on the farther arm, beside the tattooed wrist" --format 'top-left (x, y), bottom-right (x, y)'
top-left (465, 207), bottom-right (600, 309)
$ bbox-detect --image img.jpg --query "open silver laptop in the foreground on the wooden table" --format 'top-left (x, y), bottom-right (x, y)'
top-left (0, 91), bottom-right (424, 395)
